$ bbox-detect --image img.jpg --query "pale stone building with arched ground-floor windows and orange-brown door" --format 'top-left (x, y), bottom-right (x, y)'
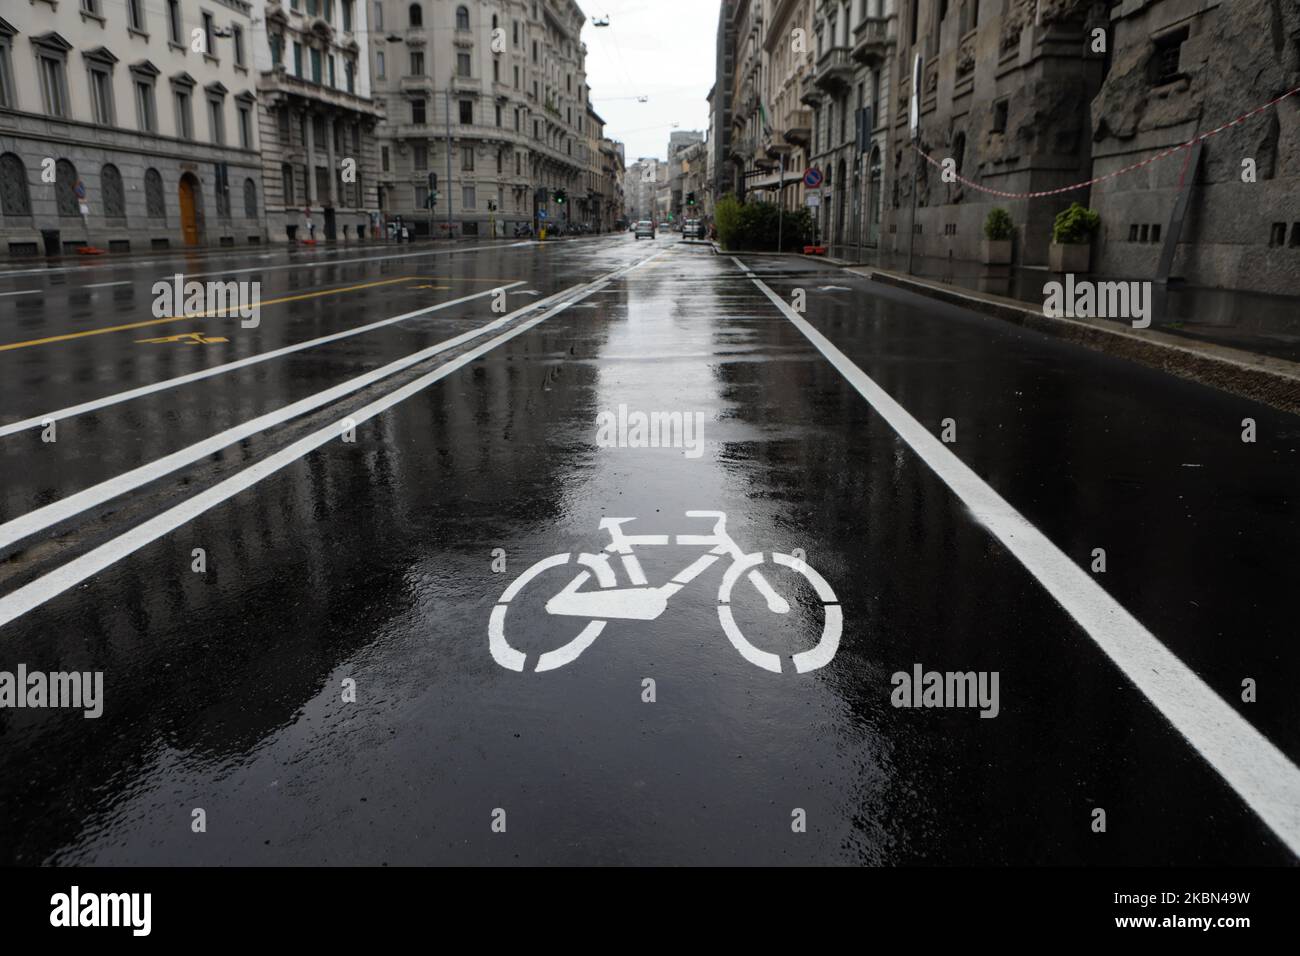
top-left (0, 0), bottom-right (265, 256)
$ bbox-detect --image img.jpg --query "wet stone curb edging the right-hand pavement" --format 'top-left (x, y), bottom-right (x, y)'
top-left (850, 269), bottom-right (1300, 414)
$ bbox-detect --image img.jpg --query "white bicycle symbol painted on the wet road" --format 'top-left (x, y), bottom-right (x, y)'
top-left (488, 511), bottom-right (844, 674)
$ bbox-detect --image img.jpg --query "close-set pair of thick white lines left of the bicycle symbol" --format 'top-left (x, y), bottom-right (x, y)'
top-left (0, 252), bottom-right (663, 627)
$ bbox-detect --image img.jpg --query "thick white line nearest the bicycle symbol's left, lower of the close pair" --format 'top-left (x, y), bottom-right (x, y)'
top-left (0, 252), bottom-right (663, 627)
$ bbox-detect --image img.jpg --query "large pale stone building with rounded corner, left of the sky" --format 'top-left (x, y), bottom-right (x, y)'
top-left (371, 0), bottom-right (588, 235)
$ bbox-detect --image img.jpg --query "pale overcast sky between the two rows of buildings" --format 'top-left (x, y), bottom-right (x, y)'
top-left (577, 0), bottom-right (719, 165)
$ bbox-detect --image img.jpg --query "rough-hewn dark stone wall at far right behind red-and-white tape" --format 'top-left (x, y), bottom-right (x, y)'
top-left (1089, 0), bottom-right (1300, 295)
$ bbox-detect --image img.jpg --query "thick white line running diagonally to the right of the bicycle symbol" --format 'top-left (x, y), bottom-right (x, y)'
top-left (732, 258), bottom-right (1300, 856)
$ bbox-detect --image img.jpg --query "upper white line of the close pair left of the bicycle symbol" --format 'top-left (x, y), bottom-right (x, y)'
top-left (0, 277), bottom-right (582, 553)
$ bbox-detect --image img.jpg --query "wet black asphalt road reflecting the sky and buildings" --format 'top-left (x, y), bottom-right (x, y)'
top-left (0, 235), bottom-right (1300, 865)
